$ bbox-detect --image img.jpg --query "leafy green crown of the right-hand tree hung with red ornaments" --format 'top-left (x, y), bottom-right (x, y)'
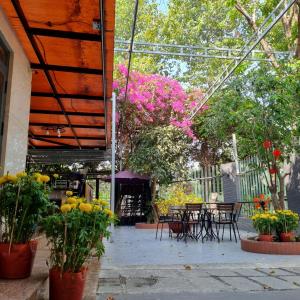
top-left (195, 61), bottom-right (300, 163)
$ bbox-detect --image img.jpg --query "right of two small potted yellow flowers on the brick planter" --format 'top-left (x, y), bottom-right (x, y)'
top-left (276, 210), bottom-right (299, 242)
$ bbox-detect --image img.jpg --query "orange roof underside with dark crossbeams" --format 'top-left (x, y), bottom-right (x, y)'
top-left (0, 0), bottom-right (115, 150)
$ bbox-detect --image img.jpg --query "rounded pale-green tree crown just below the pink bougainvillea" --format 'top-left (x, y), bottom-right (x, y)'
top-left (129, 125), bottom-right (189, 183)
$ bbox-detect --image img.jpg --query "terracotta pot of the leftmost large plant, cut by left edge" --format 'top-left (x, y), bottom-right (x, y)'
top-left (0, 240), bottom-right (37, 279)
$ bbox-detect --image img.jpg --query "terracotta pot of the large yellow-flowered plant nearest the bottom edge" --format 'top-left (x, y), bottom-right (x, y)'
top-left (49, 267), bottom-right (87, 300)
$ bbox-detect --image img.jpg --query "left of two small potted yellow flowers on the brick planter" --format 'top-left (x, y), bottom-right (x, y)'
top-left (252, 212), bottom-right (278, 242)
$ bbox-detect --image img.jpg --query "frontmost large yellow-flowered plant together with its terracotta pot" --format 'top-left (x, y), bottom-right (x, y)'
top-left (42, 193), bottom-right (114, 300)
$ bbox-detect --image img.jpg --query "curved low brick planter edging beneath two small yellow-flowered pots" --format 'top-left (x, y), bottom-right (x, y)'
top-left (241, 239), bottom-right (300, 255)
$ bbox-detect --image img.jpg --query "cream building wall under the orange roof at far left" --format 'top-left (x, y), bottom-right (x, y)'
top-left (0, 7), bottom-right (32, 174)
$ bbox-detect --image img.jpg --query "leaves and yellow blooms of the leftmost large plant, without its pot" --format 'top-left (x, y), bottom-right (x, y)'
top-left (0, 172), bottom-right (51, 244)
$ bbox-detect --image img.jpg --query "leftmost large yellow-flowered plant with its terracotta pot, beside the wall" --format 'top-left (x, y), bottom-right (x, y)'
top-left (0, 172), bottom-right (50, 279)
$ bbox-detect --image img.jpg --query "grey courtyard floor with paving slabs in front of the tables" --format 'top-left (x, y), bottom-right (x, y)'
top-left (98, 227), bottom-right (300, 300)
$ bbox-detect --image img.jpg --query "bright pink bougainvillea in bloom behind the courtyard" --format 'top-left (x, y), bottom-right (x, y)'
top-left (114, 65), bottom-right (207, 138)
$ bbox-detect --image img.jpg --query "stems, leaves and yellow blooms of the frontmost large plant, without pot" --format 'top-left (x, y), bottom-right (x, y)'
top-left (42, 193), bottom-right (115, 273)
